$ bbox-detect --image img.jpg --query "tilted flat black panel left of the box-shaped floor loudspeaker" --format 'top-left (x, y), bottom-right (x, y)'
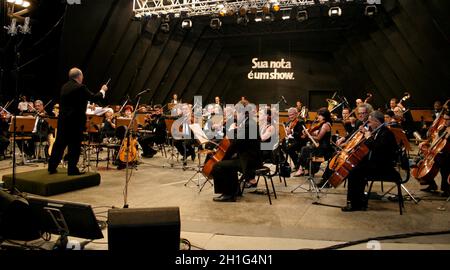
top-left (27, 196), bottom-right (103, 250)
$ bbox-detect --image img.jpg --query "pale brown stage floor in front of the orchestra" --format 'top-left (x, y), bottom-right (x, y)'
top-left (0, 146), bottom-right (450, 250)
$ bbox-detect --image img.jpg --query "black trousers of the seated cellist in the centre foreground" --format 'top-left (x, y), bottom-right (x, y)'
top-left (212, 159), bottom-right (241, 196)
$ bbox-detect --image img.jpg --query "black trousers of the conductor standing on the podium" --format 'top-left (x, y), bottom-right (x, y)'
top-left (48, 125), bottom-right (83, 171)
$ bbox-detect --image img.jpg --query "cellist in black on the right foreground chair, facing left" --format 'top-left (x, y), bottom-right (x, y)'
top-left (342, 111), bottom-right (398, 212)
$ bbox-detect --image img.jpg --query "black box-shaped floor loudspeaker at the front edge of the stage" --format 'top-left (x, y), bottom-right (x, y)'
top-left (108, 207), bottom-right (180, 251)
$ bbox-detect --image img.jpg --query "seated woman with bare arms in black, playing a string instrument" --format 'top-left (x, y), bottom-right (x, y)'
top-left (294, 107), bottom-right (333, 177)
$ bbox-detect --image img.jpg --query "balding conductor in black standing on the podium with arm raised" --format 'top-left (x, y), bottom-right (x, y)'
top-left (48, 67), bottom-right (108, 175)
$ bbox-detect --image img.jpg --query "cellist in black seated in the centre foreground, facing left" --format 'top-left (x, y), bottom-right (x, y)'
top-left (212, 105), bottom-right (261, 202)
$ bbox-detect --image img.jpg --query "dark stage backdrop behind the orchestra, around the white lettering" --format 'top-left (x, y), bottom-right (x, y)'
top-left (3, 0), bottom-right (450, 108)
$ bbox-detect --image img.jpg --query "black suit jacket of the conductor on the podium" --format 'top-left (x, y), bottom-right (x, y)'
top-left (58, 80), bottom-right (103, 130)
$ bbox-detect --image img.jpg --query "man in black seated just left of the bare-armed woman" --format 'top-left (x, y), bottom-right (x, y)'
top-left (285, 107), bottom-right (306, 170)
